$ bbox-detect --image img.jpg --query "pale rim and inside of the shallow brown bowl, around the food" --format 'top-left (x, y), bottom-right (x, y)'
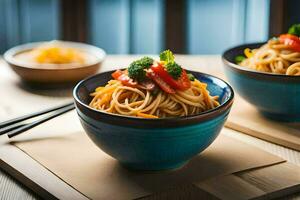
top-left (3, 40), bottom-right (106, 71)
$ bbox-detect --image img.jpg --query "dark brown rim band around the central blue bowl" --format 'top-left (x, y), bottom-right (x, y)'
top-left (73, 70), bottom-right (234, 128)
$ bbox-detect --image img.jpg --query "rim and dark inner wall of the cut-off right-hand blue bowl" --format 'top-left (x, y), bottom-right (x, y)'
top-left (222, 42), bottom-right (300, 83)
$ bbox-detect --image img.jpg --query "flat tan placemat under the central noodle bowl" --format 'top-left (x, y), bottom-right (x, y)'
top-left (15, 125), bottom-right (286, 199)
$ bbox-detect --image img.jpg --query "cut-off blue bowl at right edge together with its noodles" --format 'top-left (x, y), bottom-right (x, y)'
top-left (222, 25), bottom-right (300, 122)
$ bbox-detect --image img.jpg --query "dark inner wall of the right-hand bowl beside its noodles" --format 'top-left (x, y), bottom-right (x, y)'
top-left (223, 42), bottom-right (265, 64)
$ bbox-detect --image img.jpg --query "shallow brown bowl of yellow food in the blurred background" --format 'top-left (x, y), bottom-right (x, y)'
top-left (4, 40), bottom-right (106, 85)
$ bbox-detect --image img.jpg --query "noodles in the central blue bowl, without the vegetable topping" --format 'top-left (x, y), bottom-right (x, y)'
top-left (90, 80), bottom-right (219, 118)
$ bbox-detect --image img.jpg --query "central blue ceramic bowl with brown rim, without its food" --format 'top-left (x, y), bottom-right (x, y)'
top-left (73, 71), bottom-right (234, 170)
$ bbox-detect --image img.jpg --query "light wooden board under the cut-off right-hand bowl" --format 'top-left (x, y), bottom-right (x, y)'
top-left (226, 95), bottom-right (300, 151)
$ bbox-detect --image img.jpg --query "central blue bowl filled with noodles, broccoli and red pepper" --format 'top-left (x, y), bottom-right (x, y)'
top-left (73, 50), bottom-right (234, 170)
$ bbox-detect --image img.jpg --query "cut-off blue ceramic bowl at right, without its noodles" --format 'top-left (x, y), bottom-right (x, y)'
top-left (222, 43), bottom-right (300, 122)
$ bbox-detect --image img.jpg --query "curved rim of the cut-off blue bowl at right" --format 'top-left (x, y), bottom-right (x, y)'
top-left (222, 42), bottom-right (300, 80)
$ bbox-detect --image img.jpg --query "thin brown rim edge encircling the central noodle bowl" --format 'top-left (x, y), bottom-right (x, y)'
top-left (73, 70), bottom-right (235, 123)
